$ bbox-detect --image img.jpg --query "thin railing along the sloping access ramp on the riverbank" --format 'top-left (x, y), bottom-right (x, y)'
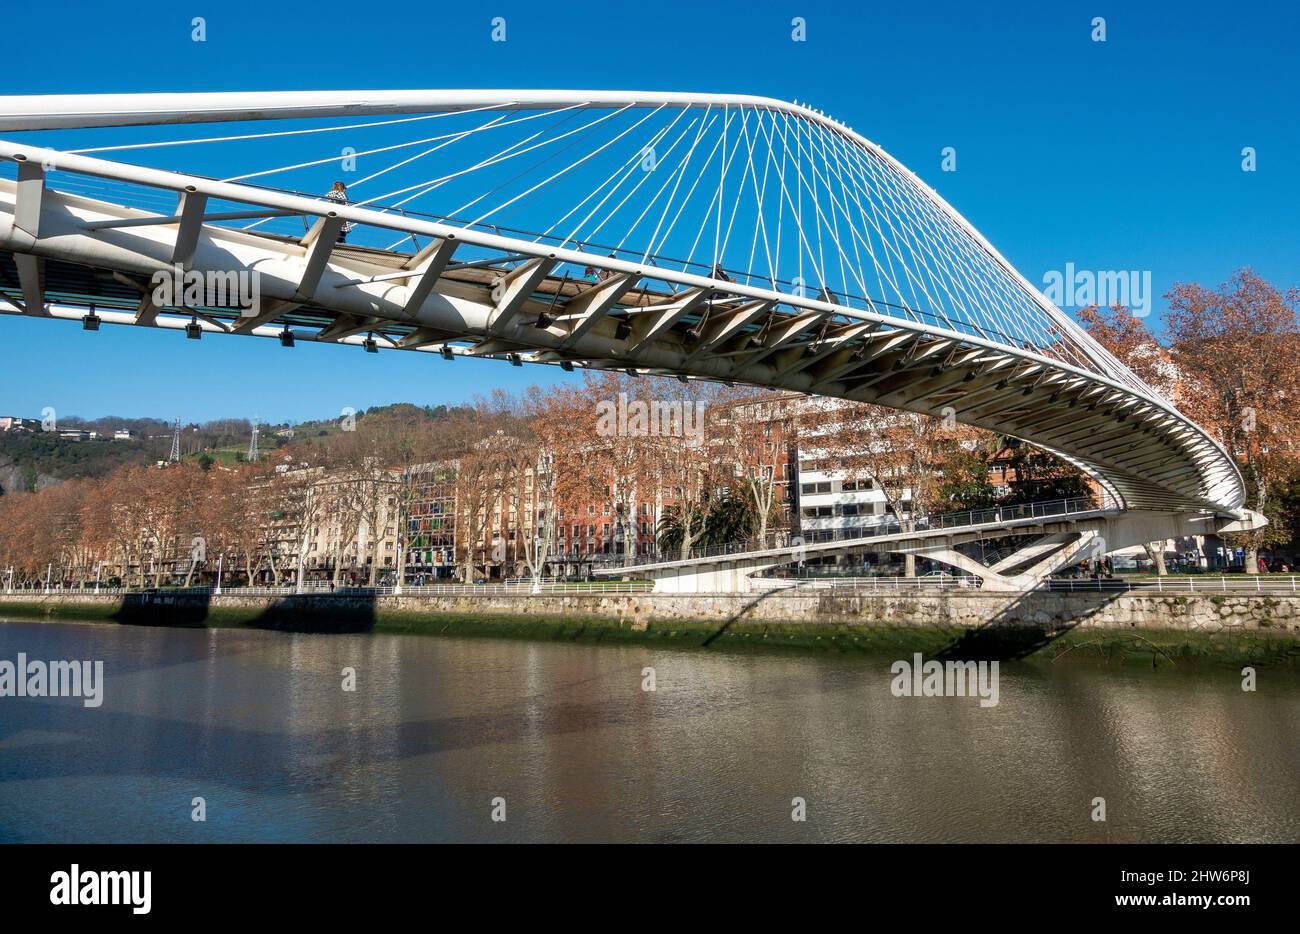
top-left (592, 497), bottom-right (1102, 570)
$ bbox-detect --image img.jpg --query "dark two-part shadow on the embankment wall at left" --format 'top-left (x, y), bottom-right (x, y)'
top-left (111, 589), bottom-right (377, 632)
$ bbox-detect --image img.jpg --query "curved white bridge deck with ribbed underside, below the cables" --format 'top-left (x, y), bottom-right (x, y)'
top-left (0, 170), bottom-right (1240, 520)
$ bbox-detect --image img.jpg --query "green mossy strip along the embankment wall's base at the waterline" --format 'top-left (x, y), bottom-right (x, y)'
top-left (0, 596), bottom-right (1300, 667)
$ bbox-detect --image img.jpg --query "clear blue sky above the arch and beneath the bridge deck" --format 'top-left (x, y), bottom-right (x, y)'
top-left (0, 0), bottom-right (1300, 421)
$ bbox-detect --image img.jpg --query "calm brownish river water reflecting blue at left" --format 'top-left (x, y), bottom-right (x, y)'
top-left (0, 622), bottom-right (1300, 842)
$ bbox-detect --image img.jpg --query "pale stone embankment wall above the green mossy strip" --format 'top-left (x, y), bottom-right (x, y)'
top-left (0, 591), bottom-right (1300, 636)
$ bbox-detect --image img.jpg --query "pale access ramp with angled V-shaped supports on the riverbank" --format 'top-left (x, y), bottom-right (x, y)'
top-left (613, 510), bottom-right (1262, 593)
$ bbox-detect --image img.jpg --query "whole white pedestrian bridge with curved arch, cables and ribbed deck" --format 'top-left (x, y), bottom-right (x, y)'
top-left (0, 90), bottom-right (1262, 585)
